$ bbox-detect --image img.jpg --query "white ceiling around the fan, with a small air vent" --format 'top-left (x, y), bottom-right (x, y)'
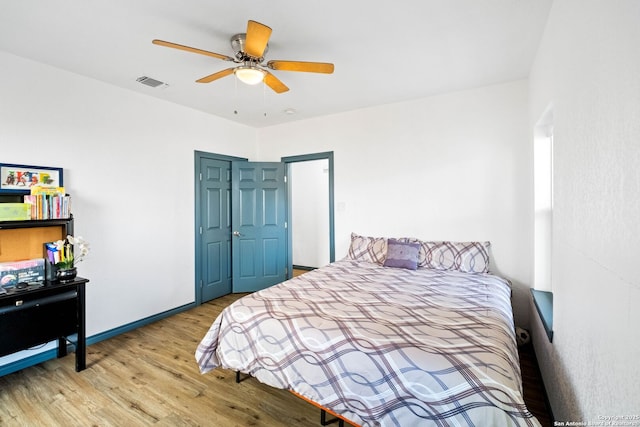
top-left (0, 0), bottom-right (552, 127)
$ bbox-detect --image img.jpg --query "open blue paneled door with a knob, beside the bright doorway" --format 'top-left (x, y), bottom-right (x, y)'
top-left (231, 162), bottom-right (287, 293)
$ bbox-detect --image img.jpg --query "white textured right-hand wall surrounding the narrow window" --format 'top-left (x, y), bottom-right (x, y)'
top-left (530, 0), bottom-right (640, 422)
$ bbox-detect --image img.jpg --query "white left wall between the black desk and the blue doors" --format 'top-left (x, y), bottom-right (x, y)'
top-left (0, 52), bottom-right (256, 348)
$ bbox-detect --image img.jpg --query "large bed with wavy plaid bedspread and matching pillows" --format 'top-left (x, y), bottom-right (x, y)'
top-left (196, 234), bottom-right (540, 427)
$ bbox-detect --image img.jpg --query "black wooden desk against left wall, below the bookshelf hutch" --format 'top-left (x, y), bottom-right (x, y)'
top-left (0, 277), bottom-right (89, 372)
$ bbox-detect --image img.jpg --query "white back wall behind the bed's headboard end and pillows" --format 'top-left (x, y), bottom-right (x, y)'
top-left (258, 81), bottom-right (533, 326)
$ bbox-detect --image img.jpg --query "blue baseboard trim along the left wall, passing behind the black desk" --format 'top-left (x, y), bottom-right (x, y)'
top-left (0, 302), bottom-right (196, 377)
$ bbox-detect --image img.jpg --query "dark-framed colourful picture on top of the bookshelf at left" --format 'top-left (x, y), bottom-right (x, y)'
top-left (0, 163), bottom-right (64, 194)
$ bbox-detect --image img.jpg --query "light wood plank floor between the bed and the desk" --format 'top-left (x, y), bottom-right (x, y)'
top-left (0, 282), bottom-right (546, 427)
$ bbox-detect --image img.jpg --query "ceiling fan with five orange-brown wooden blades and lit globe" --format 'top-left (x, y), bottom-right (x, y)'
top-left (153, 20), bottom-right (333, 93)
